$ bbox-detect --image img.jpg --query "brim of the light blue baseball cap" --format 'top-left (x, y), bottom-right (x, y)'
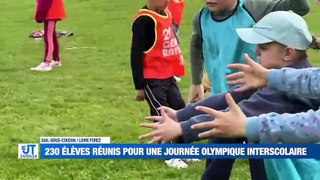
top-left (236, 28), bottom-right (273, 44)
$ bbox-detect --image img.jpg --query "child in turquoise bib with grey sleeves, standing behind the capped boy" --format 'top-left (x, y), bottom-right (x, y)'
top-left (189, 0), bottom-right (310, 180)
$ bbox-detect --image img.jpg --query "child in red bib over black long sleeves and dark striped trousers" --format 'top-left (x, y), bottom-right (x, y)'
top-left (131, 0), bottom-right (188, 168)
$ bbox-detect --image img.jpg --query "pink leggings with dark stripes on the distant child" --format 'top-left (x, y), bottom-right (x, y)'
top-left (43, 21), bottom-right (60, 63)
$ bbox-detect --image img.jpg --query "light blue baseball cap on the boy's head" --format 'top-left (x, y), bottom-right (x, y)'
top-left (236, 11), bottom-right (312, 50)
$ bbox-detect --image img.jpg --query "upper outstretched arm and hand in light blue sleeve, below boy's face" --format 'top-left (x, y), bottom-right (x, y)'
top-left (227, 55), bottom-right (320, 98)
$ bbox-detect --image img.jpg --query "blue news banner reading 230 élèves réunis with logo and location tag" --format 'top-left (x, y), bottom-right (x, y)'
top-left (18, 137), bottom-right (320, 159)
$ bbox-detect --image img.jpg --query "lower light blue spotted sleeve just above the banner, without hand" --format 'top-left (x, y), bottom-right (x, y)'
top-left (246, 109), bottom-right (320, 143)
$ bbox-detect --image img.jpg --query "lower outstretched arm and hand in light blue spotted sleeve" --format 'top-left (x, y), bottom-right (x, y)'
top-left (192, 94), bottom-right (320, 143)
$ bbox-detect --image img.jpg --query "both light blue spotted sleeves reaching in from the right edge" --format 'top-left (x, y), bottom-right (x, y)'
top-left (247, 68), bottom-right (320, 143)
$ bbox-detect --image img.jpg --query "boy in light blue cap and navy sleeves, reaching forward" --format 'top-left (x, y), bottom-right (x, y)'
top-left (142, 11), bottom-right (320, 179)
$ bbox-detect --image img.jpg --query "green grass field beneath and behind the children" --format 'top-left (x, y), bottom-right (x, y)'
top-left (0, 0), bottom-right (320, 180)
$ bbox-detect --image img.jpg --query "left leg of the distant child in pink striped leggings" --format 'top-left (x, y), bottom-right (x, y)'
top-left (43, 21), bottom-right (56, 64)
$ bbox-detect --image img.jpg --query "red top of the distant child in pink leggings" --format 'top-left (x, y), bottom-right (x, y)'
top-left (35, 0), bottom-right (66, 23)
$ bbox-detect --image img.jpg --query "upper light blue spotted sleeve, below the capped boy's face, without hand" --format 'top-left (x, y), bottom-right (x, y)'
top-left (268, 68), bottom-right (320, 99)
